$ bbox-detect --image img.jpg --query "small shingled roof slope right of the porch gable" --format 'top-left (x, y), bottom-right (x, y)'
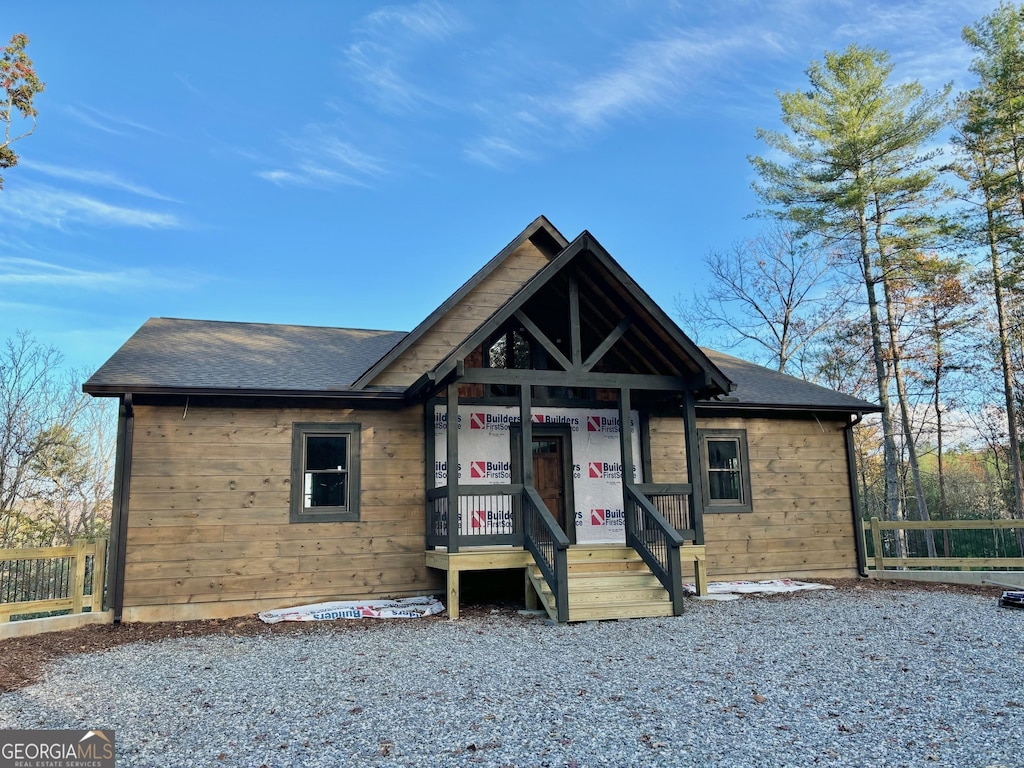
top-left (697, 348), bottom-right (882, 414)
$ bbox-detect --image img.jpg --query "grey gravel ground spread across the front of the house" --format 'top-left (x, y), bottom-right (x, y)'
top-left (0, 590), bottom-right (1024, 768)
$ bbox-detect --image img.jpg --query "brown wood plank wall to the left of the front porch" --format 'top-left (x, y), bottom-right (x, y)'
top-left (124, 406), bottom-right (443, 622)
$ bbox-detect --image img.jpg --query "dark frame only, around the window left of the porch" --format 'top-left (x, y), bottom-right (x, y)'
top-left (289, 422), bottom-right (362, 522)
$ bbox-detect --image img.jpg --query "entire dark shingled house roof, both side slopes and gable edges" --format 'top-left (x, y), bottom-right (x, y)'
top-left (82, 216), bottom-right (880, 413)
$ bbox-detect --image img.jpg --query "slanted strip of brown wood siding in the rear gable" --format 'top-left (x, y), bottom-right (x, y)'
top-left (371, 240), bottom-right (548, 386)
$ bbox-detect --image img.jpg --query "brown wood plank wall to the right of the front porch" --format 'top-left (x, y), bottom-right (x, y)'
top-left (650, 417), bottom-right (857, 581)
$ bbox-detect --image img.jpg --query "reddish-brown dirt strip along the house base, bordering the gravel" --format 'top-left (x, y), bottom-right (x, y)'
top-left (0, 579), bottom-right (1002, 693)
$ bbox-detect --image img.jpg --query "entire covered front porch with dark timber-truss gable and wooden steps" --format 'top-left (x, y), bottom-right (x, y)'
top-left (408, 232), bottom-right (731, 622)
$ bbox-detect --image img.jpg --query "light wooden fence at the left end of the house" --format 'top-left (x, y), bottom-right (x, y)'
top-left (0, 541), bottom-right (106, 623)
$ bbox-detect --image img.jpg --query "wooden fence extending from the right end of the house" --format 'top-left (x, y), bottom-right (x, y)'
top-left (863, 517), bottom-right (1024, 570)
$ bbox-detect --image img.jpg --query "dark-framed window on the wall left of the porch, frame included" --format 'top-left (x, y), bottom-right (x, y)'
top-left (291, 424), bottom-right (359, 522)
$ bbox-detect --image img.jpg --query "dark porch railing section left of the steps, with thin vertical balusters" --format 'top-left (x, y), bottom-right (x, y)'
top-left (427, 483), bottom-right (522, 547)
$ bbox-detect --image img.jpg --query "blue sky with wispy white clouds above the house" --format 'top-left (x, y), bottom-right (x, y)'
top-left (0, 0), bottom-right (995, 370)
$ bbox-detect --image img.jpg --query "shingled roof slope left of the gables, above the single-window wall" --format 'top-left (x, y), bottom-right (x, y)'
top-left (82, 317), bottom-right (406, 396)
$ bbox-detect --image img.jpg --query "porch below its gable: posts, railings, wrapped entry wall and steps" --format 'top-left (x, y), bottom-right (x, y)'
top-left (425, 382), bottom-right (707, 622)
